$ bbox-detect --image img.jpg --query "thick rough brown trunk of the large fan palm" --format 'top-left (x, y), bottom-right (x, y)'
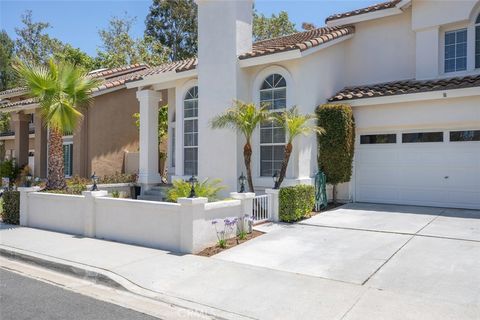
top-left (47, 128), bottom-right (67, 190)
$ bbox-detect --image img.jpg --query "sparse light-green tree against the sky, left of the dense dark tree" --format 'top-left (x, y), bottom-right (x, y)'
top-left (96, 15), bottom-right (168, 68)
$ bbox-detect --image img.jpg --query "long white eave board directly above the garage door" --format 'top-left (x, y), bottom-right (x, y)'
top-left (329, 87), bottom-right (480, 107)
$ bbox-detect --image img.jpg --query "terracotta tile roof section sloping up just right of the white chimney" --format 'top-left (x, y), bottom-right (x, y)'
top-left (239, 26), bottom-right (355, 59)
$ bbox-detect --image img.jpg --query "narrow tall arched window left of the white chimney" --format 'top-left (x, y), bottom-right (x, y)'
top-left (183, 86), bottom-right (198, 176)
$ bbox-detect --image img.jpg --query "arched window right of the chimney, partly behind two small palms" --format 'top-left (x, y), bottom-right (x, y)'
top-left (260, 74), bottom-right (287, 177)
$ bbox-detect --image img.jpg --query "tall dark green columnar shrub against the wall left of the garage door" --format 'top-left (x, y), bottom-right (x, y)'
top-left (316, 104), bottom-right (355, 202)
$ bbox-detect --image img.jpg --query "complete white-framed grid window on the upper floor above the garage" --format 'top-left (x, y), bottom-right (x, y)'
top-left (445, 29), bottom-right (467, 73)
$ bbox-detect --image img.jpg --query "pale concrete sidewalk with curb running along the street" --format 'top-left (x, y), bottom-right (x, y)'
top-left (0, 224), bottom-right (368, 319)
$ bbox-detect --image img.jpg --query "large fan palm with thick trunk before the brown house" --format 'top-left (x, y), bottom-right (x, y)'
top-left (14, 59), bottom-right (99, 189)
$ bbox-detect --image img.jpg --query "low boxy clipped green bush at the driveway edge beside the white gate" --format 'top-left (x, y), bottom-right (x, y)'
top-left (279, 185), bottom-right (315, 222)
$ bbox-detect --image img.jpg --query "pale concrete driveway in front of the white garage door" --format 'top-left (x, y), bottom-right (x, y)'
top-left (215, 204), bottom-right (480, 319)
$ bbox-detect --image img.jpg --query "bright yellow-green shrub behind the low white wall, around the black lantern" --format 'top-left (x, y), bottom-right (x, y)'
top-left (167, 179), bottom-right (225, 202)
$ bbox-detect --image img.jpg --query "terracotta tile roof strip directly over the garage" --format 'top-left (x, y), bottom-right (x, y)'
top-left (329, 75), bottom-right (480, 102)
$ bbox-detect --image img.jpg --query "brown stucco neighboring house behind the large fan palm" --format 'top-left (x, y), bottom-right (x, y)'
top-left (0, 65), bottom-right (152, 177)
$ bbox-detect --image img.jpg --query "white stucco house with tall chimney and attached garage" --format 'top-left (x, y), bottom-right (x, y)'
top-left (127, 0), bottom-right (480, 209)
